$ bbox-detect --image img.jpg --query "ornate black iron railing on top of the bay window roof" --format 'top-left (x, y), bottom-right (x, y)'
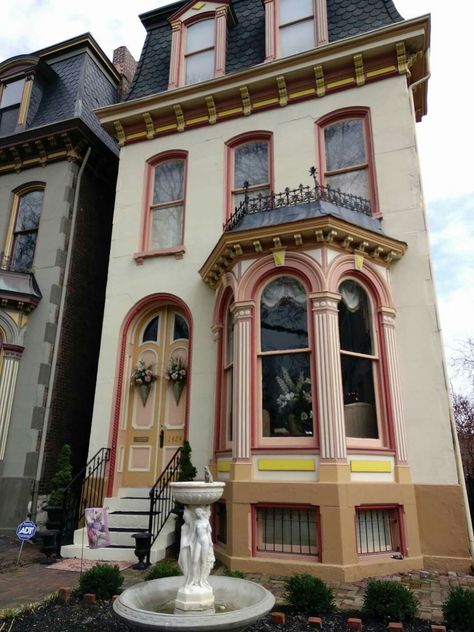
top-left (224, 167), bottom-right (372, 232)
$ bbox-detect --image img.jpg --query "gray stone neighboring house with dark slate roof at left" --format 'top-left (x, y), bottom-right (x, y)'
top-left (0, 34), bottom-right (133, 531)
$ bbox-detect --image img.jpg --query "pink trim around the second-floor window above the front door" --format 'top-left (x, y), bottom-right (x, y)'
top-left (138, 150), bottom-right (188, 256)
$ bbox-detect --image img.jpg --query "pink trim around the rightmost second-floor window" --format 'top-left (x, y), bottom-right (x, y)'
top-left (316, 107), bottom-right (382, 217)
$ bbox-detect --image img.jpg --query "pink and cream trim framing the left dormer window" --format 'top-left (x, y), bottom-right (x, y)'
top-left (168, 4), bottom-right (228, 90)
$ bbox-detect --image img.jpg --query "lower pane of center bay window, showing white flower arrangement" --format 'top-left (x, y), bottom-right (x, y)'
top-left (262, 353), bottom-right (313, 437)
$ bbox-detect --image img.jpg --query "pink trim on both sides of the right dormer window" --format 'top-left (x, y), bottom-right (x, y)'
top-left (264, 0), bottom-right (329, 62)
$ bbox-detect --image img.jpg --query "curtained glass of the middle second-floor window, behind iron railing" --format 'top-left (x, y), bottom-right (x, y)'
top-left (232, 140), bottom-right (271, 210)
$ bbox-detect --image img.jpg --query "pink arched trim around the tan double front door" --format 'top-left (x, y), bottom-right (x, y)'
top-left (107, 293), bottom-right (193, 496)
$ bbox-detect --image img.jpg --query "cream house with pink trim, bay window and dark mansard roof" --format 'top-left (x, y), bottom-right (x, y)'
top-left (84, 0), bottom-right (471, 580)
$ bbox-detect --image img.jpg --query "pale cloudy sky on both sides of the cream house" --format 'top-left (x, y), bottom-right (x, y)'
top-left (0, 0), bottom-right (474, 390)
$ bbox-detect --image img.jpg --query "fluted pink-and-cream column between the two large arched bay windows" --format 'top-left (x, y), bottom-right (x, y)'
top-left (311, 292), bottom-right (347, 465)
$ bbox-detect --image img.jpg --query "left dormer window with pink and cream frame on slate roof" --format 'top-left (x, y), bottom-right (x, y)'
top-left (168, 0), bottom-right (234, 90)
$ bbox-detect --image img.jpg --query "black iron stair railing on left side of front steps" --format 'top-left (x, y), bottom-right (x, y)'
top-left (61, 448), bottom-right (110, 544)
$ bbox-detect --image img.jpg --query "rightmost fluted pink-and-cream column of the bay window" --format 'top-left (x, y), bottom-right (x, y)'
top-left (379, 307), bottom-right (408, 474)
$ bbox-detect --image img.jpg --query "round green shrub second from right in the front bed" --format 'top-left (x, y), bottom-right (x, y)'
top-left (362, 579), bottom-right (419, 623)
